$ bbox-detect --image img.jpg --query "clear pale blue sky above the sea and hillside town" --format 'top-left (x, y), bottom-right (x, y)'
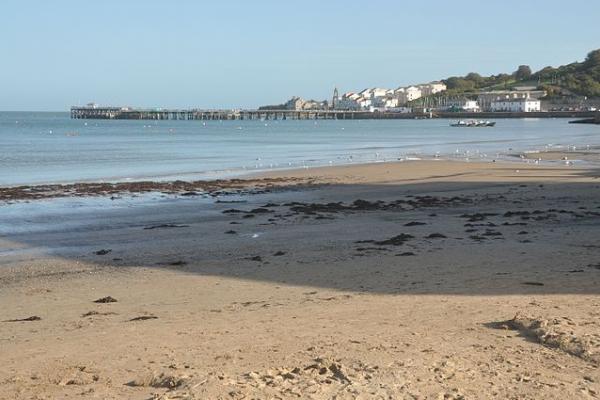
top-left (0, 0), bottom-right (600, 110)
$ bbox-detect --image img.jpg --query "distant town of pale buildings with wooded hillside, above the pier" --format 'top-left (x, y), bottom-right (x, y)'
top-left (259, 50), bottom-right (600, 114)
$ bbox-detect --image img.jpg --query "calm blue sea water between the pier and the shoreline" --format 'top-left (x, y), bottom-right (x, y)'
top-left (0, 112), bottom-right (600, 186)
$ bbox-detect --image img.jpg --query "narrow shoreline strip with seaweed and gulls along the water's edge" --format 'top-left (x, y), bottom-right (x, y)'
top-left (0, 146), bottom-right (600, 202)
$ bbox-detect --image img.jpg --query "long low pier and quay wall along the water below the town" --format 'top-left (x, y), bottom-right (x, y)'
top-left (71, 106), bottom-right (598, 121)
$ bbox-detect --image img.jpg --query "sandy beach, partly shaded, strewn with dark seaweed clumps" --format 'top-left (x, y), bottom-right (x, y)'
top-left (0, 160), bottom-right (600, 400)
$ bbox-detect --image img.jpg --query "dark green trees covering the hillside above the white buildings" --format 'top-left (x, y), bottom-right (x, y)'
top-left (443, 50), bottom-right (600, 97)
